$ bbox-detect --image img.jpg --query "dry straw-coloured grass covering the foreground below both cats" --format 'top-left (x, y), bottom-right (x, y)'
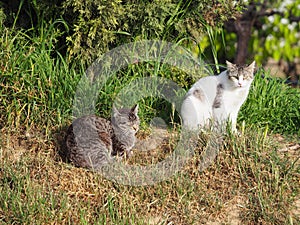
top-left (0, 125), bottom-right (300, 224)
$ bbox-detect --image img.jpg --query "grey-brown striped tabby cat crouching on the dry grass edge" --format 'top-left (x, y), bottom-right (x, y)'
top-left (66, 105), bottom-right (140, 170)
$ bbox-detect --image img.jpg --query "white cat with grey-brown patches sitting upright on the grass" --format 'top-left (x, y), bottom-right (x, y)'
top-left (181, 61), bottom-right (255, 131)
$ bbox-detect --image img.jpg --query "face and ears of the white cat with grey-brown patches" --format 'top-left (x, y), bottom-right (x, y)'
top-left (226, 61), bottom-right (255, 88)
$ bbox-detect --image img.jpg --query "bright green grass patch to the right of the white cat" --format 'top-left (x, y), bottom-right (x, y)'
top-left (239, 70), bottom-right (300, 136)
